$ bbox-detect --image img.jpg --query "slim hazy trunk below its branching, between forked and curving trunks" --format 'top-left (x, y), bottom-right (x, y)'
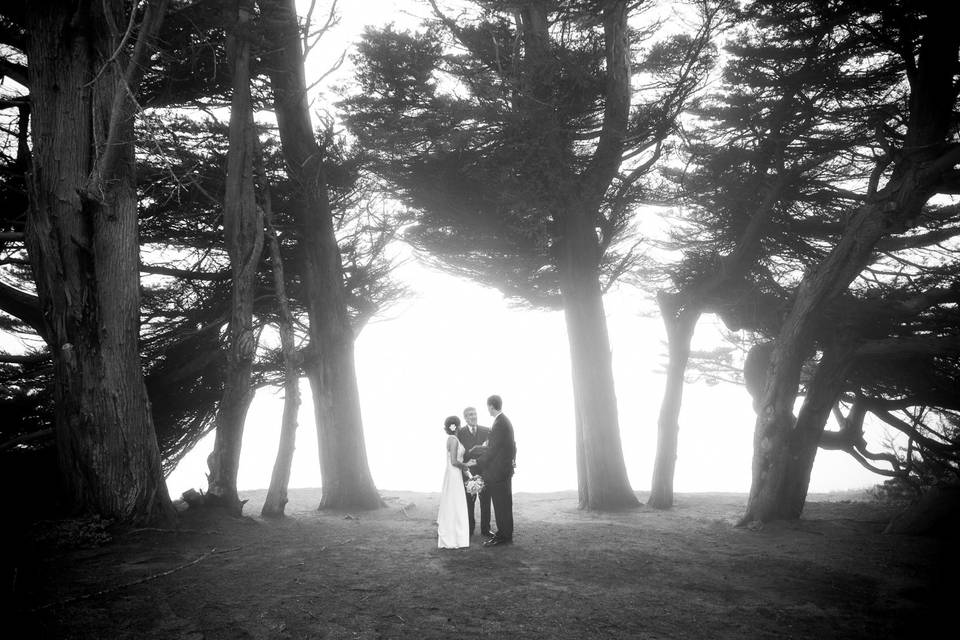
top-left (647, 293), bottom-right (700, 509)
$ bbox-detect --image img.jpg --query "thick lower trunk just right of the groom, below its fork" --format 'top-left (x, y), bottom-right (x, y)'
top-left (560, 212), bottom-right (639, 510)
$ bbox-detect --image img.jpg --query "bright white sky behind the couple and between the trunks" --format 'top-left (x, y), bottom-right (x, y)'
top-left (161, 0), bottom-right (880, 497)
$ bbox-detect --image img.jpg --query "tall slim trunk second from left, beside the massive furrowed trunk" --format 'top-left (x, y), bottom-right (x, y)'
top-left (207, 0), bottom-right (263, 515)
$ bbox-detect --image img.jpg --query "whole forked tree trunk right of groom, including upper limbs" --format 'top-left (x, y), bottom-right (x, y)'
top-left (548, 0), bottom-right (639, 510)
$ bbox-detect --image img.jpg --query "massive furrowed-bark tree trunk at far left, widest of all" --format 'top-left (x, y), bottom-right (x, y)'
top-left (24, 0), bottom-right (173, 522)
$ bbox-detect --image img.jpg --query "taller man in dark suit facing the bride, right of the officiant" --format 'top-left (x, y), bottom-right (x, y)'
top-left (476, 395), bottom-right (517, 547)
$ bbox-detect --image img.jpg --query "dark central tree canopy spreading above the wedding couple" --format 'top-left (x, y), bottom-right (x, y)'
top-left (343, 2), bottom-right (713, 307)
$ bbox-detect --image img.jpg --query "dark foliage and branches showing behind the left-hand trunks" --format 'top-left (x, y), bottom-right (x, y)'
top-left (0, 2), bottom-right (403, 496)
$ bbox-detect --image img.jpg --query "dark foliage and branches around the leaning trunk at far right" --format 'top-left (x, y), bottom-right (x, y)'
top-left (670, 2), bottom-right (960, 516)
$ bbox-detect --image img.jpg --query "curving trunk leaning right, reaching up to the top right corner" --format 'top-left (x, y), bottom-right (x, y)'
top-left (741, 3), bottom-right (960, 523)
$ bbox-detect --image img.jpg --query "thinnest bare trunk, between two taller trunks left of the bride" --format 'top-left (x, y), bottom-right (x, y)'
top-left (257, 169), bottom-right (300, 518)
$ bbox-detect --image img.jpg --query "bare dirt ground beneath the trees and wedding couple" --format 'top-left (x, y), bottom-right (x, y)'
top-left (4, 490), bottom-right (958, 640)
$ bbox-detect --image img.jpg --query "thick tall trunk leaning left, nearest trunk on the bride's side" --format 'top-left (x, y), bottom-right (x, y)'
top-left (261, 0), bottom-right (383, 509)
